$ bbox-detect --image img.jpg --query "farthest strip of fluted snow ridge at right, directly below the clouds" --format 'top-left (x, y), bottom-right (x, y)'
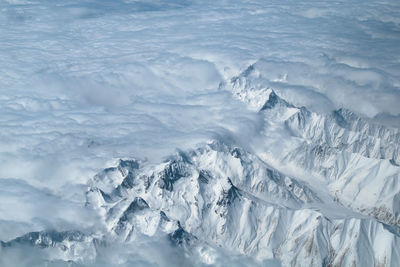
top-left (286, 109), bottom-right (400, 165)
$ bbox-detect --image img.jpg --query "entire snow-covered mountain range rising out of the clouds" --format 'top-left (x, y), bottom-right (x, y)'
top-left (1, 63), bottom-right (400, 266)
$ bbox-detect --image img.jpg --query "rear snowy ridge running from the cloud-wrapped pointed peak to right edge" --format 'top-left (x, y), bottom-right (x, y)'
top-left (227, 61), bottom-right (400, 226)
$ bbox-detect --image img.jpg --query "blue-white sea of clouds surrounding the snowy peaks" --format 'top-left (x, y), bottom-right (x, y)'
top-left (0, 0), bottom-right (400, 266)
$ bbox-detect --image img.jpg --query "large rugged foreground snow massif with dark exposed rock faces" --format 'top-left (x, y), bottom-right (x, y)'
top-left (83, 141), bottom-right (399, 266)
